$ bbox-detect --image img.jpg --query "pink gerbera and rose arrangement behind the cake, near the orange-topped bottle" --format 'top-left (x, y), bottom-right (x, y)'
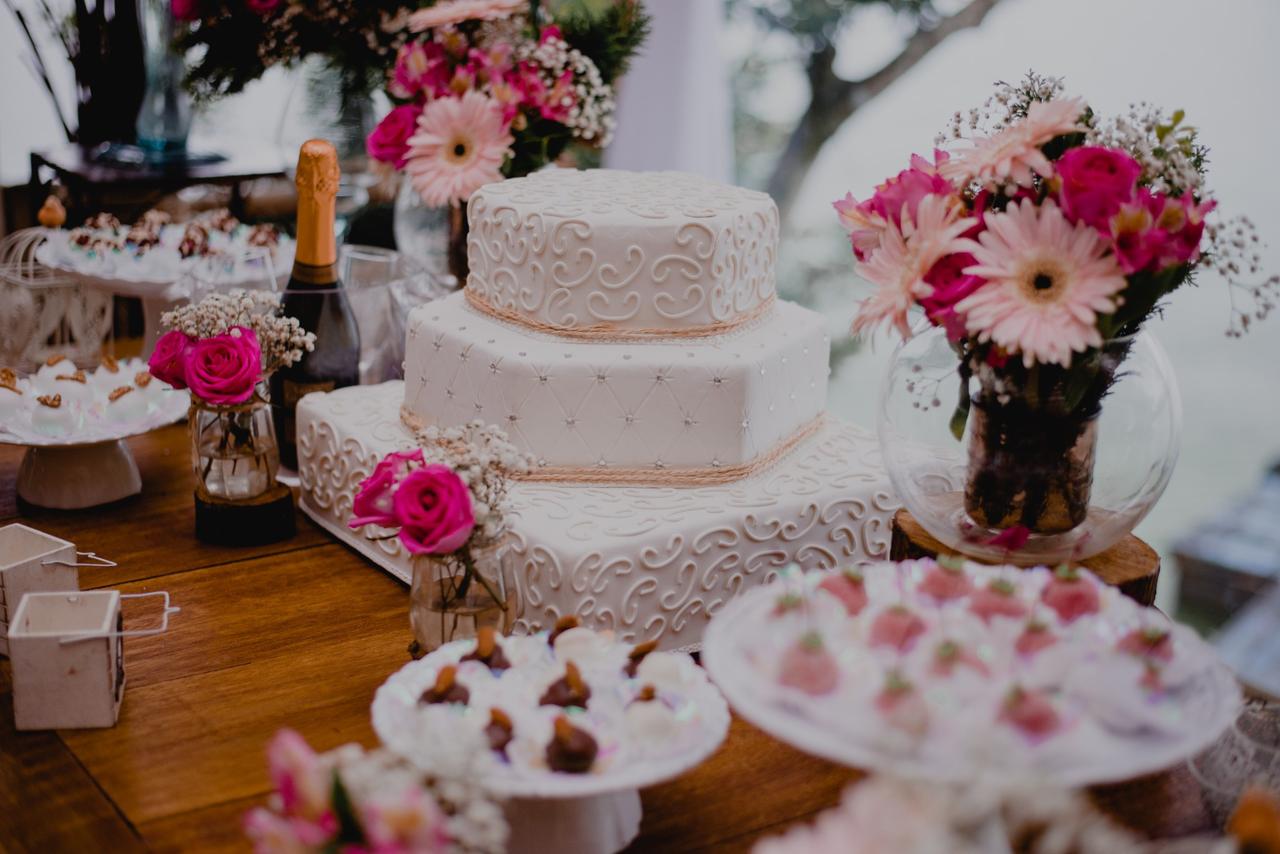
top-left (369, 0), bottom-right (649, 206)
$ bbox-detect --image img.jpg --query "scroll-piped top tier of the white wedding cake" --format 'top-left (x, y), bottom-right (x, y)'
top-left (467, 169), bottom-right (778, 334)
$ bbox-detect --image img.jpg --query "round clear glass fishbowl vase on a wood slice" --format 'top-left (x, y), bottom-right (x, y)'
top-left (877, 328), bottom-right (1181, 566)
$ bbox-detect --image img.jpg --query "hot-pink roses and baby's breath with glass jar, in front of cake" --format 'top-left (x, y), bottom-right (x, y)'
top-left (348, 421), bottom-right (530, 654)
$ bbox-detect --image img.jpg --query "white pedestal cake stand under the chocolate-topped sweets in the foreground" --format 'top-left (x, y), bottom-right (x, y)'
top-left (372, 640), bottom-right (730, 854)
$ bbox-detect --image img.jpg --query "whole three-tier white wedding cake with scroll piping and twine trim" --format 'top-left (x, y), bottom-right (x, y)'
top-left (298, 170), bottom-right (895, 648)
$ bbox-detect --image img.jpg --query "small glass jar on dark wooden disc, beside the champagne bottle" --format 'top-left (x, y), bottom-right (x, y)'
top-left (188, 384), bottom-right (280, 503)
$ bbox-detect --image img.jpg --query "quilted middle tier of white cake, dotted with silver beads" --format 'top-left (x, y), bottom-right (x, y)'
top-left (404, 293), bottom-right (831, 480)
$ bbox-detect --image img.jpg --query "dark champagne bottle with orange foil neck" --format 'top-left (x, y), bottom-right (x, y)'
top-left (271, 140), bottom-right (360, 470)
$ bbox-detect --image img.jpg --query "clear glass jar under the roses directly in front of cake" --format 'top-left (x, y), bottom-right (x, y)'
top-left (408, 543), bottom-right (517, 654)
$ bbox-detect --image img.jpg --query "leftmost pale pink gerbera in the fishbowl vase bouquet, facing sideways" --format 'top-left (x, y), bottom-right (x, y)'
top-left (852, 195), bottom-right (977, 338)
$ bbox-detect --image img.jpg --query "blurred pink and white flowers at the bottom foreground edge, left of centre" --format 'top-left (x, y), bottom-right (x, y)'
top-left (244, 730), bottom-right (508, 854)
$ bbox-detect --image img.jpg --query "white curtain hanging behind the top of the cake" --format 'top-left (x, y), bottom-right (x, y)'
top-left (604, 0), bottom-right (733, 183)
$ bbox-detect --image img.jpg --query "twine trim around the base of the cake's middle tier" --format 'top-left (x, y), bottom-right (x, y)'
top-left (401, 406), bottom-right (826, 487)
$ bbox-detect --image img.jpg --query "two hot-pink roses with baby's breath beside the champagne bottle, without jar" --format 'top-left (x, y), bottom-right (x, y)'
top-left (148, 289), bottom-right (316, 406)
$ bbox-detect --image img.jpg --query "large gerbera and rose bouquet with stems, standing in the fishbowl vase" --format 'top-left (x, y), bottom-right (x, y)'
top-left (835, 73), bottom-right (1280, 557)
